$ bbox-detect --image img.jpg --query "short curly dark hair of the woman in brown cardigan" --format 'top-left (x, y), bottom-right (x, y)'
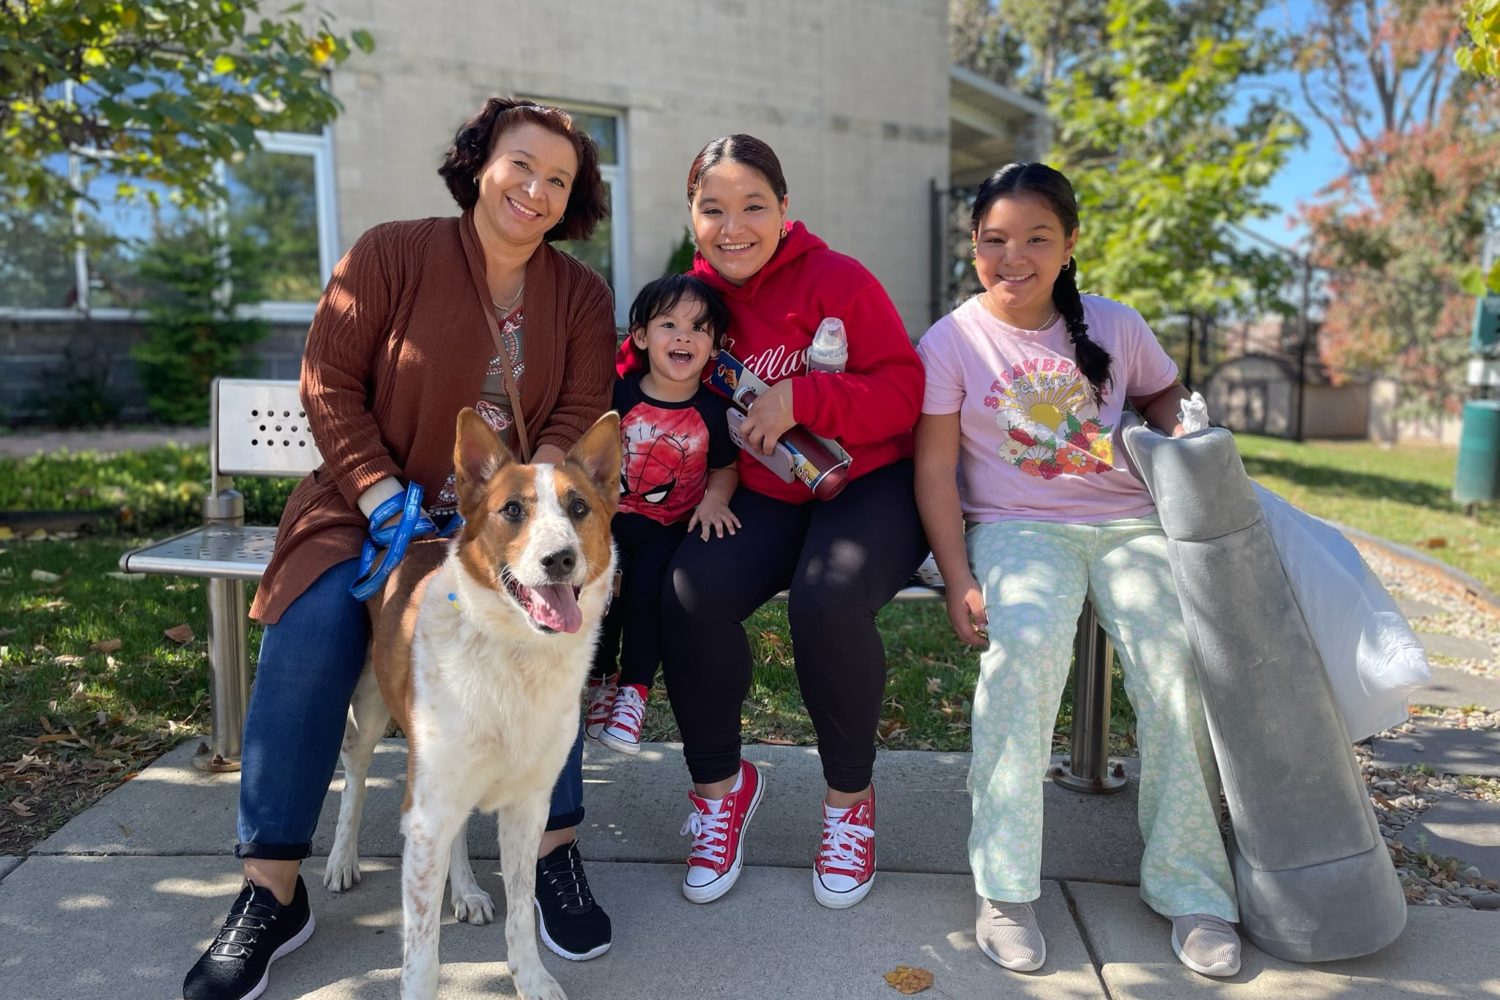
top-left (438, 97), bottom-right (609, 241)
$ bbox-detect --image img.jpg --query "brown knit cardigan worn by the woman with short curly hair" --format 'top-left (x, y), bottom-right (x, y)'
top-left (251, 211), bottom-right (615, 625)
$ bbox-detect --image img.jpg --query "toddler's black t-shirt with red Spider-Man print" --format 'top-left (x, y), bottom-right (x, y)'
top-left (614, 372), bottom-right (738, 525)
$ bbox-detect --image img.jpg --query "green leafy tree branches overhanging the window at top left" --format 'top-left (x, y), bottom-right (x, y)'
top-left (0, 0), bottom-right (374, 216)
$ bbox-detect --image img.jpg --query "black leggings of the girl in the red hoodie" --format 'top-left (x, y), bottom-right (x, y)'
top-left (662, 460), bottom-right (927, 792)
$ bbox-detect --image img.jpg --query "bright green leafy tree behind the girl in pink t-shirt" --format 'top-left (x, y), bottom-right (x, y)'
top-left (1049, 0), bottom-right (1304, 375)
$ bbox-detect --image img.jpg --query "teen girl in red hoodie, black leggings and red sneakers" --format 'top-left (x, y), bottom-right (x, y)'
top-left (662, 135), bottom-right (927, 909)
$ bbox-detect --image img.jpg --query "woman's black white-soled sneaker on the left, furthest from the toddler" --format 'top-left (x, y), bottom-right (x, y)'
top-left (183, 876), bottom-right (314, 1000)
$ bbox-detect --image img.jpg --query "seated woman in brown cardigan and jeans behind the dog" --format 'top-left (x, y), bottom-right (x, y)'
top-left (183, 99), bottom-right (615, 1000)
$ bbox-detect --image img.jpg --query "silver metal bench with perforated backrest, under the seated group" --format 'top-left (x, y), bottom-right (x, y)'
top-left (120, 378), bottom-right (1125, 793)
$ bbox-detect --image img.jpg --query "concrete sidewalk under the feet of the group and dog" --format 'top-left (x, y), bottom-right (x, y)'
top-left (0, 741), bottom-right (1500, 1000)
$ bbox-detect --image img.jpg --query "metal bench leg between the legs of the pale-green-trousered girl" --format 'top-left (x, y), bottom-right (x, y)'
top-left (1052, 603), bottom-right (1125, 795)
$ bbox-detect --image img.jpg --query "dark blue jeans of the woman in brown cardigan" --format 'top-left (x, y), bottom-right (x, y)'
top-left (234, 559), bottom-right (584, 861)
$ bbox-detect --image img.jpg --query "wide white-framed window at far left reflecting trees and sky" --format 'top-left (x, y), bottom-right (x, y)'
top-left (0, 132), bottom-right (338, 321)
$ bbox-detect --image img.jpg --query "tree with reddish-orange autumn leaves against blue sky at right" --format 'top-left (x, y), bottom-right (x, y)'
top-left (1296, 0), bottom-right (1500, 412)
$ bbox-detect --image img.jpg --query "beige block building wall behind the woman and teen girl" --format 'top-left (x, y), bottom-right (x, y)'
top-left (321, 0), bottom-right (1044, 333)
